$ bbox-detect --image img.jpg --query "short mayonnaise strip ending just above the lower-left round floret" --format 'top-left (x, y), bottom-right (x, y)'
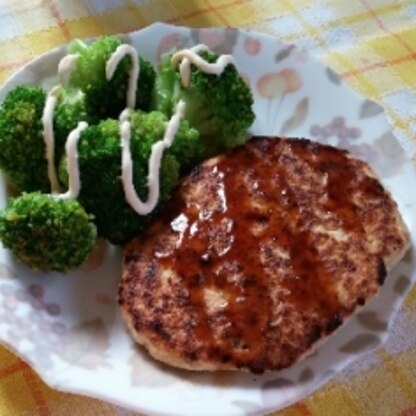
top-left (56, 121), bottom-right (88, 199)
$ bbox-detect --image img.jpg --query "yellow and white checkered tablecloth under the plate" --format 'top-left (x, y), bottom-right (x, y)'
top-left (0, 0), bottom-right (416, 416)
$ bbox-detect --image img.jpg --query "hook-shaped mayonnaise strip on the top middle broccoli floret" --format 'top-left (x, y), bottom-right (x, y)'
top-left (106, 45), bottom-right (140, 108)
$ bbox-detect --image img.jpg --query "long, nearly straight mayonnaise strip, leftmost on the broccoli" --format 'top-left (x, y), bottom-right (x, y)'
top-left (42, 85), bottom-right (60, 194)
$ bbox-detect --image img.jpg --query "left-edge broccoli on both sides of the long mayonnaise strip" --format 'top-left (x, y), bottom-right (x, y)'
top-left (0, 85), bottom-right (90, 192)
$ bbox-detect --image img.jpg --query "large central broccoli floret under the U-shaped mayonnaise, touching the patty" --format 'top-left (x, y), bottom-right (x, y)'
top-left (60, 111), bottom-right (196, 245)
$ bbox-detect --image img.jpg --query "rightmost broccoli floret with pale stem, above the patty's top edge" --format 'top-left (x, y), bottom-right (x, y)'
top-left (152, 51), bottom-right (255, 157)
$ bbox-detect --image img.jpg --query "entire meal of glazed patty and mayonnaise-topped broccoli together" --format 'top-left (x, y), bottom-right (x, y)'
top-left (0, 36), bottom-right (409, 373)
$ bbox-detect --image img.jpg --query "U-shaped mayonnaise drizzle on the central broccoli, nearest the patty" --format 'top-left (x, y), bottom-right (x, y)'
top-left (120, 101), bottom-right (185, 215)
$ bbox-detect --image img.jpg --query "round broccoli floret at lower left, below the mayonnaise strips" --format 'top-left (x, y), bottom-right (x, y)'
top-left (0, 192), bottom-right (96, 273)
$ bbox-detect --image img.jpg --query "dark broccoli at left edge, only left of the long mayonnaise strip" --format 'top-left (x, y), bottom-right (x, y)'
top-left (0, 86), bottom-right (50, 192)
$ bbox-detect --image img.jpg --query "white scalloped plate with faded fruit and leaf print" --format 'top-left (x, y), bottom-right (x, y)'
top-left (0, 24), bottom-right (416, 416)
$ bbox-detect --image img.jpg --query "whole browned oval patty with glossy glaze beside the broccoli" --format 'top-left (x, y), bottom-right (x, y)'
top-left (118, 138), bottom-right (410, 373)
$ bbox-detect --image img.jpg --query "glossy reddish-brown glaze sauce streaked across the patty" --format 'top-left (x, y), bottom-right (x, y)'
top-left (160, 138), bottom-right (370, 365)
